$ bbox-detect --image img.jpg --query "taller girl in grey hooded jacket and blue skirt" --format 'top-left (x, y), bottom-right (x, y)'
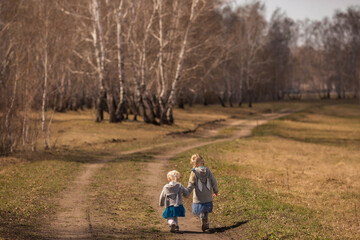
top-left (187, 154), bottom-right (219, 231)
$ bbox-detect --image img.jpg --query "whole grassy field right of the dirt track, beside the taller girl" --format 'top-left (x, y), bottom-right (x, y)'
top-left (169, 100), bottom-right (360, 239)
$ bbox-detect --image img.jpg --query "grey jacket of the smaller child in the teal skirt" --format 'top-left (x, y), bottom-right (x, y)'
top-left (159, 182), bottom-right (190, 208)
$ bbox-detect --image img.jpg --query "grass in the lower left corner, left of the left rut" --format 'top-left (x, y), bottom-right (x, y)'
top-left (0, 156), bottom-right (81, 239)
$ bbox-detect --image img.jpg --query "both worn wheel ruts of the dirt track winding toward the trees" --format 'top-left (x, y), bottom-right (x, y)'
top-left (50, 111), bottom-right (290, 240)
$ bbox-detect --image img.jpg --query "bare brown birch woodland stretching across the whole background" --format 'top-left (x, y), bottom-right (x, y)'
top-left (0, 0), bottom-right (360, 153)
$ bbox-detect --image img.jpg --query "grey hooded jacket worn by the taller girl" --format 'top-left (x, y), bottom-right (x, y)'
top-left (187, 166), bottom-right (219, 203)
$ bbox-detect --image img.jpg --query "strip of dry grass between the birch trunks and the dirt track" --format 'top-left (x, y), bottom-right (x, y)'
top-left (45, 103), bottom-right (311, 150)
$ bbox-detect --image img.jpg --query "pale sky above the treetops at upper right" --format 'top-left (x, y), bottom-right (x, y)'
top-left (236, 0), bottom-right (360, 20)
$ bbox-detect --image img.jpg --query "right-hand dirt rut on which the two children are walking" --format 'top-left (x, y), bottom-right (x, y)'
top-left (147, 113), bottom-right (287, 239)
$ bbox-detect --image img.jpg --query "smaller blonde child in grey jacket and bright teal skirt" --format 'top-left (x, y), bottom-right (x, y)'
top-left (159, 170), bottom-right (190, 232)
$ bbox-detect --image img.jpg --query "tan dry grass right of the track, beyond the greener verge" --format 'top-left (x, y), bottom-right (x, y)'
top-left (194, 101), bottom-right (360, 239)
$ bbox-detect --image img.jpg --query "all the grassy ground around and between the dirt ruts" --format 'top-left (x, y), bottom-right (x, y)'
top-left (0, 101), bottom-right (360, 239)
